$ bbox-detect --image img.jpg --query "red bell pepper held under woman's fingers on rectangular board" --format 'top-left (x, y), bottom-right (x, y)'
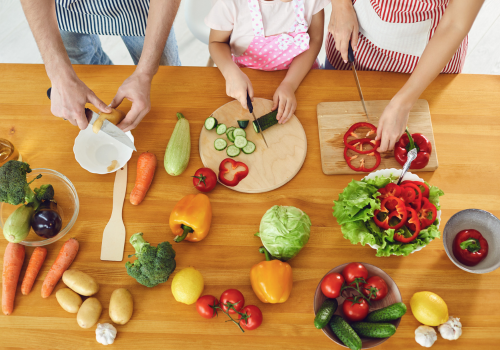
top-left (394, 129), bottom-right (432, 169)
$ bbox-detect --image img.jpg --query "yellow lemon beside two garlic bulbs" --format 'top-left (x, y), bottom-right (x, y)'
top-left (410, 292), bottom-right (448, 326)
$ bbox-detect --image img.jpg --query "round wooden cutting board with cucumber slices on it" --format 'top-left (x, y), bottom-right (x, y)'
top-left (199, 98), bottom-right (307, 193)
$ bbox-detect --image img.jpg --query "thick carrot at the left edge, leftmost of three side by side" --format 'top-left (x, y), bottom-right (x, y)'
top-left (2, 242), bottom-right (25, 315)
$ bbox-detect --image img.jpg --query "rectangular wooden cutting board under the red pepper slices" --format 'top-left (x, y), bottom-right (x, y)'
top-left (317, 100), bottom-right (438, 175)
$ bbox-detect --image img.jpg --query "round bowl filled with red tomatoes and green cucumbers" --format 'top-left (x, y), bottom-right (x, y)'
top-left (314, 262), bottom-right (407, 349)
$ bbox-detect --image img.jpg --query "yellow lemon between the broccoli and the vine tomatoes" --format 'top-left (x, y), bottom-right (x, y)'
top-left (172, 267), bottom-right (205, 305)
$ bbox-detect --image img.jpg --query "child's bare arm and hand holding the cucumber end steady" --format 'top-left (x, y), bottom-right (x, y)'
top-left (273, 10), bottom-right (325, 124)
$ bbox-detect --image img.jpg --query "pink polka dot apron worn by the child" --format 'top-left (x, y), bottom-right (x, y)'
top-left (233, 0), bottom-right (319, 71)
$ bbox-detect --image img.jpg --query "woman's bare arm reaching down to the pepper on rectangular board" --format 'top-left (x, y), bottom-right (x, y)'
top-left (376, 0), bottom-right (484, 152)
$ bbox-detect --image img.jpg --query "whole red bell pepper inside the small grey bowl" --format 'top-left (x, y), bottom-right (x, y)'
top-left (453, 230), bottom-right (488, 266)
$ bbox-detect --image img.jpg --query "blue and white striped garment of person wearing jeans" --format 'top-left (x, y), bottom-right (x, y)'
top-left (55, 0), bottom-right (149, 36)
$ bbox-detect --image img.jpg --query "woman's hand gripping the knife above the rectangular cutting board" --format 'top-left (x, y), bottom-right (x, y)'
top-left (328, 0), bottom-right (359, 63)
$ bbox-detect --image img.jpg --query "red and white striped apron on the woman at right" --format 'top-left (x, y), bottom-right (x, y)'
top-left (326, 0), bottom-right (468, 73)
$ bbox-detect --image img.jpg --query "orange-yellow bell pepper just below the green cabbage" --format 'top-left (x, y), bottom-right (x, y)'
top-left (250, 247), bottom-right (293, 304)
